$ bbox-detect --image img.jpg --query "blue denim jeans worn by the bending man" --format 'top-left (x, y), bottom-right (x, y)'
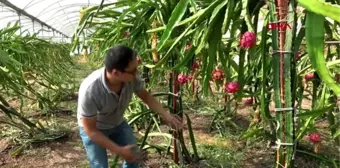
top-left (79, 121), bottom-right (138, 168)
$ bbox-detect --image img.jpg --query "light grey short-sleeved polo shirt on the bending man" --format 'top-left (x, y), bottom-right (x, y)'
top-left (77, 68), bottom-right (144, 129)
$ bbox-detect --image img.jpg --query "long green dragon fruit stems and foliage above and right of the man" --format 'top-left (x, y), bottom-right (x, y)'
top-left (73, 0), bottom-right (340, 164)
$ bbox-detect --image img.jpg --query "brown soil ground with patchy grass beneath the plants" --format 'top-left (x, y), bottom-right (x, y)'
top-left (0, 105), bottom-right (340, 168)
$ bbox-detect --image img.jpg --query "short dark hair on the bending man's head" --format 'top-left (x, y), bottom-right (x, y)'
top-left (104, 45), bottom-right (136, 72)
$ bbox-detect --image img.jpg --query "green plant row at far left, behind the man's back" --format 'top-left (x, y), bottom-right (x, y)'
top-left (0, 23), bottom-right (75, 155)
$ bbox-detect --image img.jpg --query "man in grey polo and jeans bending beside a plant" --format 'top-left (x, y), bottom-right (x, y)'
top-left (77, 45), bottom-right (182, 168)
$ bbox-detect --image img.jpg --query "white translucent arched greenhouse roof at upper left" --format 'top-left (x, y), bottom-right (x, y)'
top-left (0, 0), bottom-right (115, 37)
